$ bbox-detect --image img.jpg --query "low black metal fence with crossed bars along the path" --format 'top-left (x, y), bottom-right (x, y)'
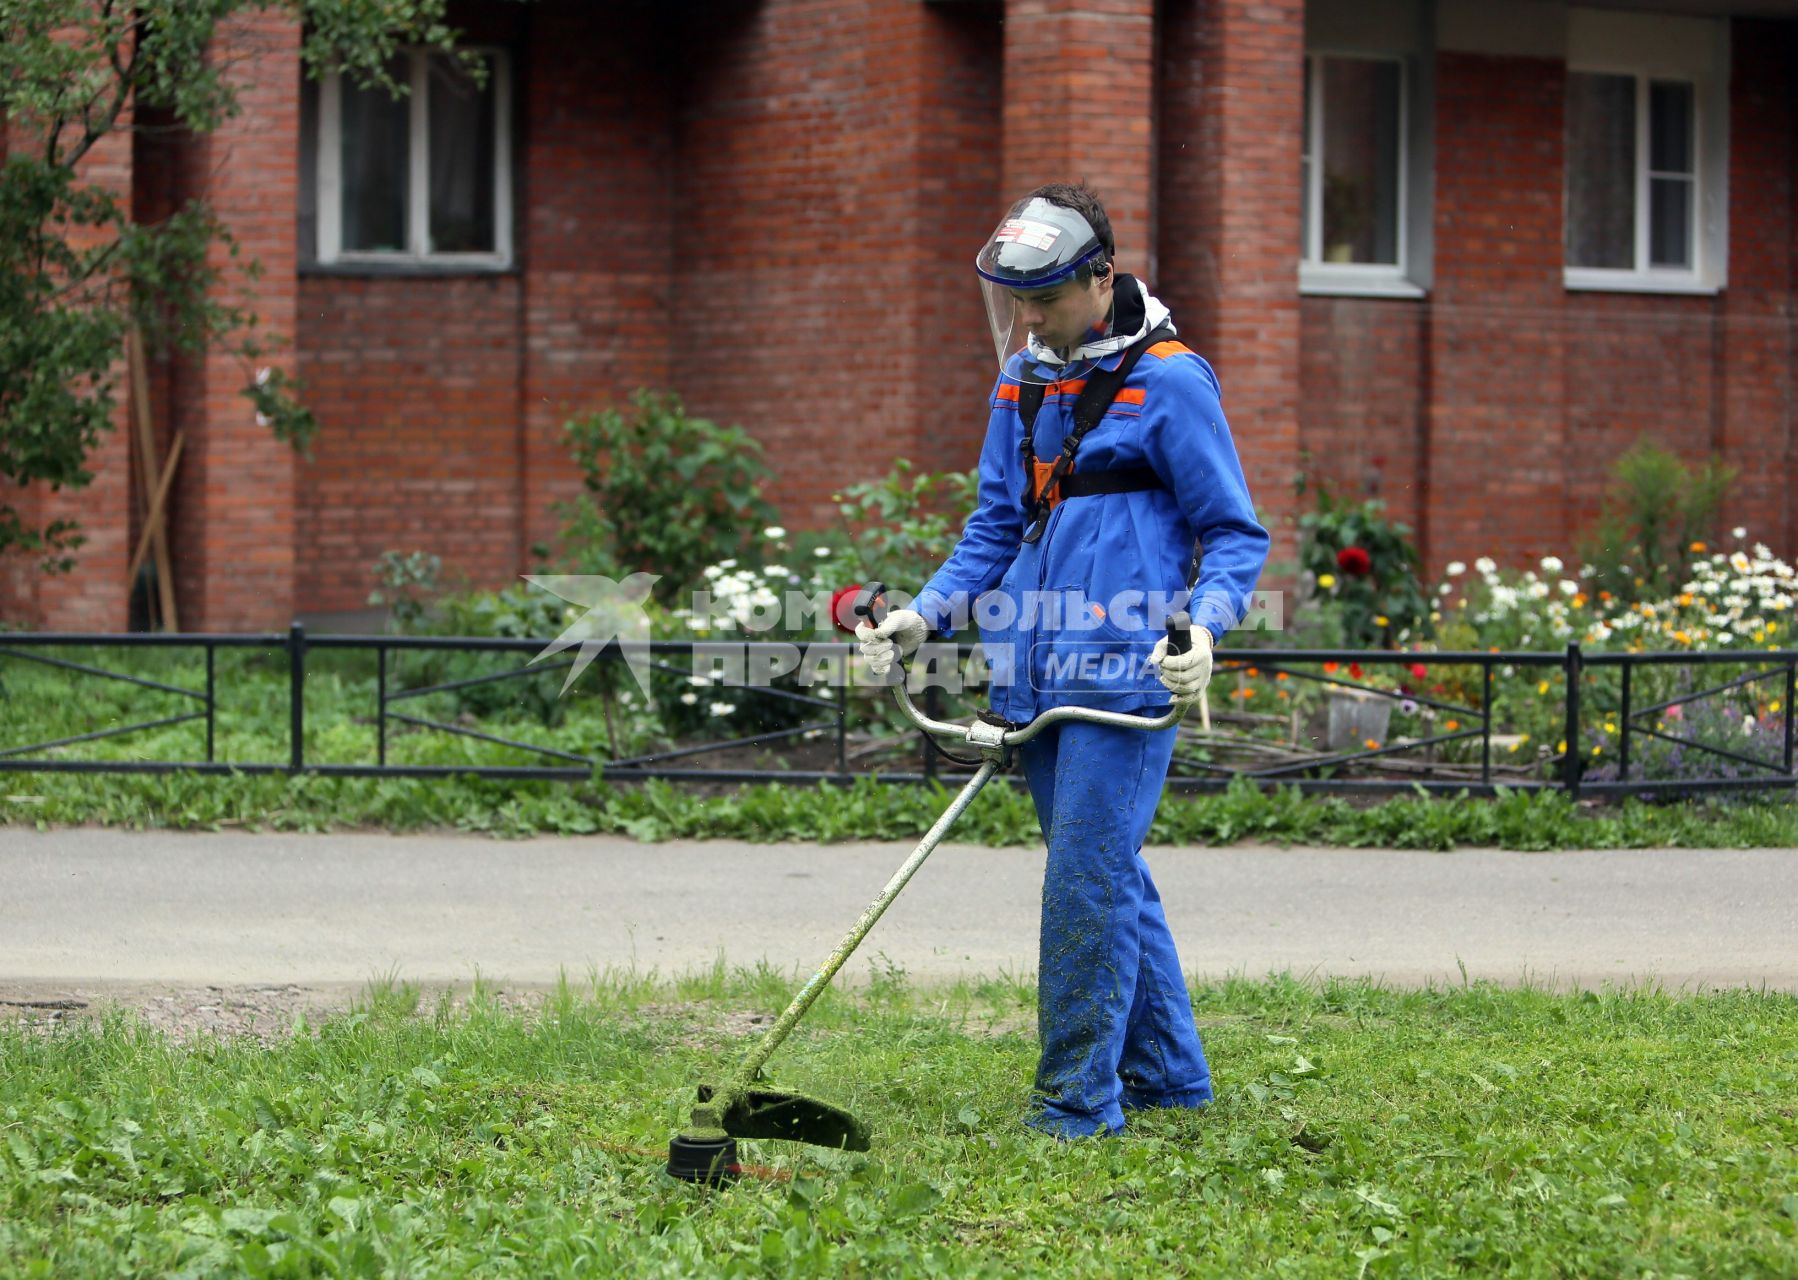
top-left (0, 624), bottom-right (1798, 798)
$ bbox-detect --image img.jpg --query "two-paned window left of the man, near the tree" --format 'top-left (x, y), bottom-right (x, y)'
top-left (300, 50), bottom-right (512, 266)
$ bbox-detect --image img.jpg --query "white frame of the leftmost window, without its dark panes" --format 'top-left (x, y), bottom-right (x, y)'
top-left (316, 45), bottom-right (512, 268)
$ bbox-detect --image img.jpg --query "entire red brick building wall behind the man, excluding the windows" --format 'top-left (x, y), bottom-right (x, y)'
top-left (17, 0), bottom-right (1798, 627)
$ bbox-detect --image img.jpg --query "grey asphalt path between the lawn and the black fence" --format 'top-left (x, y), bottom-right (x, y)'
top-left (0, 827), bottom-right (1798, 991)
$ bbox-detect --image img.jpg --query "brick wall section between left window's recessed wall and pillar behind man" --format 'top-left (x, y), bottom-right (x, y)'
top-left (674, 0), bottom-right (1001, 527)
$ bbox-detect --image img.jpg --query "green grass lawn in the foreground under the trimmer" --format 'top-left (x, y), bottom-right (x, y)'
top-left (0, 967), bottom-right (1798, 1276)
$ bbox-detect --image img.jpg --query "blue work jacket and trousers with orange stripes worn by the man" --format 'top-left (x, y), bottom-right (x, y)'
top-left (913, 325), bottom-right (1268, 1136)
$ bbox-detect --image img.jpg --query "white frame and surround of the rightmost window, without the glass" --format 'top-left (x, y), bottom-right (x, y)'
top-left (1561, 9), bottom-right (1730, 295)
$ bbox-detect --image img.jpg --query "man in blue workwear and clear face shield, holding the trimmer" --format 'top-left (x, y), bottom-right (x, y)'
top-left (858, 183), bottom-right (1268, 1138)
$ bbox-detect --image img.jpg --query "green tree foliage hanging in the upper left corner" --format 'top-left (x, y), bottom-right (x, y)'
top-left (0, 0), bottom-right (455, 572)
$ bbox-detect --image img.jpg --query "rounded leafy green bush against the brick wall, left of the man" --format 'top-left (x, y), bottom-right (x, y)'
top-left (561, 390), bottom-right (779, 602)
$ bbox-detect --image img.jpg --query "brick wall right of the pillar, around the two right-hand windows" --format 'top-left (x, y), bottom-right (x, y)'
top-left (1302, 22), bottom-right (1798, 566)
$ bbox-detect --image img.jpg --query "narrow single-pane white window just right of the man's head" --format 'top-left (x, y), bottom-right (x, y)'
top-left (1300, 54), bottom-right (1422, 297)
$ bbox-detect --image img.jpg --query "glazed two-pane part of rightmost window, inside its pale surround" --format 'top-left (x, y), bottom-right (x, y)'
top-left (1566, 72), bottom-right (1697, 277)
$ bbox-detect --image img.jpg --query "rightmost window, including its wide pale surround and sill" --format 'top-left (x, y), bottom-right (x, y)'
top-left (1564, 9), bottom-right (1730, 293)
